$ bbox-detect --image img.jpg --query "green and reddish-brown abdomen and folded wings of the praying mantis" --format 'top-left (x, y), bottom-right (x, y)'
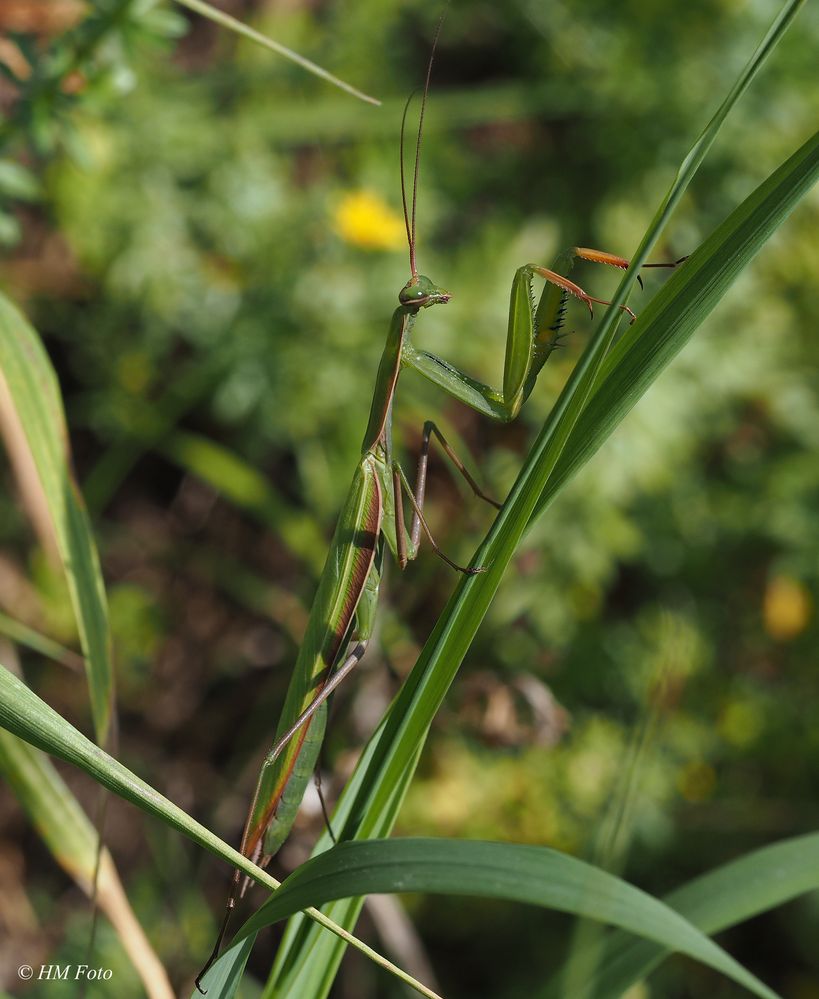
top-left (242, 455), bottom-right (383, 860)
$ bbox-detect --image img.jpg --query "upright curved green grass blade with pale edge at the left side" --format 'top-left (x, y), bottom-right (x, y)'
top-left (0, 293), bottom-right (114, 745)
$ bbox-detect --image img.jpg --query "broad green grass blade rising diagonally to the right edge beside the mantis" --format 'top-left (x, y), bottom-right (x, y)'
top-left (268, 127), bottom-right (819, 995)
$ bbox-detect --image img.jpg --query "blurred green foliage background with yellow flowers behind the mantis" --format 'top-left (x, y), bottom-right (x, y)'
top-left (0, 0), bottom-right (819, 997)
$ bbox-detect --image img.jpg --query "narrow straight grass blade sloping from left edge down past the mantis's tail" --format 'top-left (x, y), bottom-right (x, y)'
top-left (0, 666), bottom-right (436, 999)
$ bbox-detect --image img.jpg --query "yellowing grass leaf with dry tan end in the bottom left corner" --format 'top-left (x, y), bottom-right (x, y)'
top-left (0, 730), bottom-right (174, 999)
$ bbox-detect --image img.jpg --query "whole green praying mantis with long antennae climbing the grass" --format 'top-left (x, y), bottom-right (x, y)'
top-left (196, 25), bottom-right (681, 991)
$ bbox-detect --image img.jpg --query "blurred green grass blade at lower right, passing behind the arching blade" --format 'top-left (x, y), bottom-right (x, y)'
top-left (549, 833), bottom-right (819, 999)
